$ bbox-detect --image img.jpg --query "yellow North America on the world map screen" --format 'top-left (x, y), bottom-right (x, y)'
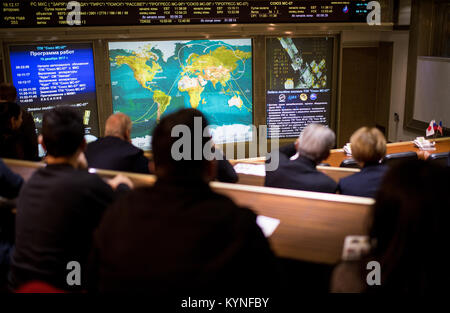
top-left (115, 53), bottom-right (161, 91)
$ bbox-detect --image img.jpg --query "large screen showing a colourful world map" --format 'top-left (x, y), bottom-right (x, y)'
top-left (109, 39), bottom-right (253, 150)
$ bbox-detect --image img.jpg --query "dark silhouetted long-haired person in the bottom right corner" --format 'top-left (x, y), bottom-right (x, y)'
top-left (331, 161), bottom-right (450, 294)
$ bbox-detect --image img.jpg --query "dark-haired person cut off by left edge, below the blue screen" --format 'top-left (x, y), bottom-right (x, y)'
top-left (0, 102), bottom-right (23, 159)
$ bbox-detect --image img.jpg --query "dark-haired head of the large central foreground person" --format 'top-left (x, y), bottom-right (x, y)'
top-left (152, 109), bottom-right (215, 181)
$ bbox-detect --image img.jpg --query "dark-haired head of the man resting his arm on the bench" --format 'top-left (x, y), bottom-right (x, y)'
top-left (39, 106), bottom-right (86, 158)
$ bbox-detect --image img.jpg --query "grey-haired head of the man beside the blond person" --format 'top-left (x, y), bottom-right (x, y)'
top-left (297, 124), bottom-right (336, 164)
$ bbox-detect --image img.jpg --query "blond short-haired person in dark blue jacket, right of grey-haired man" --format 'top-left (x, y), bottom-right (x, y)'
top-left (338, 127), bottom-right (387, 198)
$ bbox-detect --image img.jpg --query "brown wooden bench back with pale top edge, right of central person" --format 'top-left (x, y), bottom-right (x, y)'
top-left (211, 182), bottom-right (374, 264)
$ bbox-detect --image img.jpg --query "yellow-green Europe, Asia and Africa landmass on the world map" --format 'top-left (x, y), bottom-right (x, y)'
top-left (178, 46), bottom-right (251, 108)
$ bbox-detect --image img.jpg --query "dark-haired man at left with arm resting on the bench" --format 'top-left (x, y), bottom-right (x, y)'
top-left (9, 107), bottom-right (131, 290)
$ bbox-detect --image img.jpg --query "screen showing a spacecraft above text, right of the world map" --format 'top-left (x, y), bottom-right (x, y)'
top-left (266, 37), bottom-right (333, 138)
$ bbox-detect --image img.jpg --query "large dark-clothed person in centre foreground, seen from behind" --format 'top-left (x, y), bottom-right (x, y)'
top-left (89, 109), bottom-right (275, 295)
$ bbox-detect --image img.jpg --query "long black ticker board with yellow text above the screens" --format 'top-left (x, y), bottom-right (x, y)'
top-left (0, 0), bottom-right (369, 27)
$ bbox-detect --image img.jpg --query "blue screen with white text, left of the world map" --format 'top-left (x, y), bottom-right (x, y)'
top-left (9, 43), bottom-right (99, 140)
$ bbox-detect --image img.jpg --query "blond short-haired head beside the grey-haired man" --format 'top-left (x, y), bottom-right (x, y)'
top-left (350, 127), bottom-right (386, 165)
